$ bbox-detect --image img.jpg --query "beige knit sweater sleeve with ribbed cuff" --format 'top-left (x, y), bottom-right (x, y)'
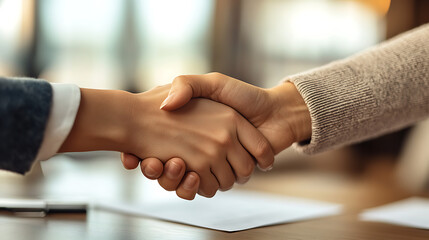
top-left (288, 24), bottom-right (429, 154)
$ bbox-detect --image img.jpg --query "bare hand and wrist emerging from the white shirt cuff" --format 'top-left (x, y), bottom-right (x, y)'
top-left (60, 86), bottom-right (274, 198)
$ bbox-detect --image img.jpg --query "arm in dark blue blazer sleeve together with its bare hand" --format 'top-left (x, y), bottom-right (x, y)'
top-left (0, 79), bottom-right (273, 198)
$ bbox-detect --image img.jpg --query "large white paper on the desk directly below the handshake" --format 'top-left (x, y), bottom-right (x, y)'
top-left (97, 190), bottom-right (341, 232)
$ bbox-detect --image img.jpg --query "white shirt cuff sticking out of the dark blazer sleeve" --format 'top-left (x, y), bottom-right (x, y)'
top-left (36, 83), bottom-right (80, 161)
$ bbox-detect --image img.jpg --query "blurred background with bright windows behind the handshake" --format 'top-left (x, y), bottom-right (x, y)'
top-left (0, 0), bottom-right (429, 204)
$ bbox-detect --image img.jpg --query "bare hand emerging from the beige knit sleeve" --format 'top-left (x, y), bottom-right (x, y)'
top-left (123, 73), bottom-right (311, 200)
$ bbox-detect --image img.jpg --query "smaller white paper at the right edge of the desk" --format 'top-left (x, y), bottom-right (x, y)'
top-left (360, 197), bottom-right (429, 229)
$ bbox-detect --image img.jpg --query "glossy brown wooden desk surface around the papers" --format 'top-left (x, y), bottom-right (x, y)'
top-left (0, 151), bottom-right (429, 240)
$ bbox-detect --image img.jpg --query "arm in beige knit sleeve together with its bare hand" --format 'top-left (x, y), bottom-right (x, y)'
top-left (163, 24), bottom-right (429, 154)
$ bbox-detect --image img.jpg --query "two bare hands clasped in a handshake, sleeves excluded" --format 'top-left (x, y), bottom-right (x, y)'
top-left (60, 73), bottom-right (311, 200)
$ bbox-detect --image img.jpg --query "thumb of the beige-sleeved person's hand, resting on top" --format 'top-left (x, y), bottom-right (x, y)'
top-left (160, 73), bottom-right (224, 111)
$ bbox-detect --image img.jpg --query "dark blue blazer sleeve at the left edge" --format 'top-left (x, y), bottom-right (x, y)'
top-left (0, 77), bottom-right (52, 174)
